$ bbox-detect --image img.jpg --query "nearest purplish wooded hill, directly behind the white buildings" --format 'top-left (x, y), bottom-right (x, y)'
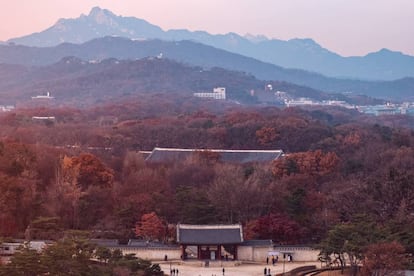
top-left (0, 57), bottom-right (352, 106)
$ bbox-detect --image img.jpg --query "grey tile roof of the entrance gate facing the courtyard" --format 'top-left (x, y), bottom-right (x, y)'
top-left (177, 224), bottom-right (243, 245)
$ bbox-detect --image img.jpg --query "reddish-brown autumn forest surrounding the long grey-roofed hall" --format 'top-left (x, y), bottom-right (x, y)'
top-left (0, 94), bottom-right (414, 268)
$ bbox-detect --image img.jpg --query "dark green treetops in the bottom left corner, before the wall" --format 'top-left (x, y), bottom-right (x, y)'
top-left (0, 233), bottom-right (164, 276)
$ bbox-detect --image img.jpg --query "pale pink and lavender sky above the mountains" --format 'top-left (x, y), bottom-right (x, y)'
top-left (0, 0), bottom-right (414, 56)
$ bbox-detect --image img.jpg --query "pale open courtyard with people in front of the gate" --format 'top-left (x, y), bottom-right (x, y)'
top-left (160, 262), bottom-right (320, 276)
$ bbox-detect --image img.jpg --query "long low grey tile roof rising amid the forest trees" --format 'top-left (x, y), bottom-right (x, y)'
top-left (145, 148), bottom-right (283, 163)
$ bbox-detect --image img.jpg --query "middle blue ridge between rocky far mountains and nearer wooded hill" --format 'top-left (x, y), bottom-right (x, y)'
top-left (0, 37), bottom-right (414, 101)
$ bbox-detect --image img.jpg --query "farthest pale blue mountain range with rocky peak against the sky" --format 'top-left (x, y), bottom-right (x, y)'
top-left (8, 7), bottom-right (414, 80)
